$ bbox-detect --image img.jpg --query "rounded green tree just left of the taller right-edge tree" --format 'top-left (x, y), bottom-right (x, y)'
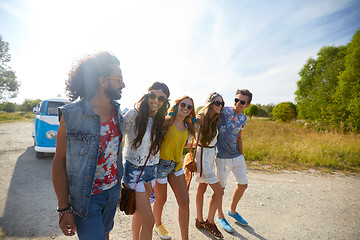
top-left (295, 46), bottom-right (346, 124)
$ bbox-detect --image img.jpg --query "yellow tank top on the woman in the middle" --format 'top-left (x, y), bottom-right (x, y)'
top-left (160, 124), bottom-right (188, 171)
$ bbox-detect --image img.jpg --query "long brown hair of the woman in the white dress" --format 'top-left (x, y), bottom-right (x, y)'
top-left (200, 92), bottom-right (224, 146)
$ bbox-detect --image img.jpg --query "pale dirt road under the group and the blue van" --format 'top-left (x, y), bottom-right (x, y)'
top-left (0, 122), bottom-right (360, 240)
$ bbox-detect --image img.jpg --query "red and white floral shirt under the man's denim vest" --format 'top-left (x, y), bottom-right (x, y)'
top-left (91, 111), bottom-right (121, 194)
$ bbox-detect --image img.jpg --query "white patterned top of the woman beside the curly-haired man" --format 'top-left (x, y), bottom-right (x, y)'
top-left (123, 109), bottom-right (159, 166)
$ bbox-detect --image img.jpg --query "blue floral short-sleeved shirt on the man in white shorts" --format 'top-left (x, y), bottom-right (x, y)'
top-left (217, 107), bottom-right (247, 158)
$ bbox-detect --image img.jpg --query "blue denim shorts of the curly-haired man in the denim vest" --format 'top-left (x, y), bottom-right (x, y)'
top-left (74, 183), bottom-right (120, 240)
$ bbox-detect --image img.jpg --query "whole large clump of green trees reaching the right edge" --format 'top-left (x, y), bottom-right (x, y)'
top-left (295, 30), bottom-right (360, 132)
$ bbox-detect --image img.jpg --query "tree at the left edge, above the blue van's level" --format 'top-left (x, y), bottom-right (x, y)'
top-left (0, 35), bottom-right (20, 100)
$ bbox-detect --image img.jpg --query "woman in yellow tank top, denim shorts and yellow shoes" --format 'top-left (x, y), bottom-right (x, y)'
top-left (153, 96), bottom-right (196, 240)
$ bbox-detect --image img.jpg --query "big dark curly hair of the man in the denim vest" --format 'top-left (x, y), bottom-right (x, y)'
top-left (65, 52), bottom-right (120, 101)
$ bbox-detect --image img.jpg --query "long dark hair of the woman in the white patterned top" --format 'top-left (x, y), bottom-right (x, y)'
top-left (132, 82), bottom-right (170, 155)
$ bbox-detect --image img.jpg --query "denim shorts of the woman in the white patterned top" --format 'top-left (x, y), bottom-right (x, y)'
top-left (123, 161), bottom-right (157, 192)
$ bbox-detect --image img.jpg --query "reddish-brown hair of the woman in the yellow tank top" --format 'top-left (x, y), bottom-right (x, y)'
top-left (163, 96), bottom-right (195, 136)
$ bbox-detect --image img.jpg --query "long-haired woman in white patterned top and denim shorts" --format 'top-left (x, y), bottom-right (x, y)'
top-left (123, 82), bottom-right (170, 239)
